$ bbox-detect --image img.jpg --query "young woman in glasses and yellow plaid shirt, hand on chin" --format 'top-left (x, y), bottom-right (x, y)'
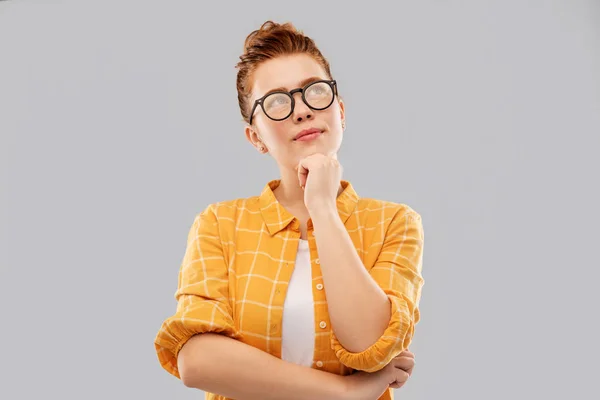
top-left (155, 21), bottom-right (424, 400)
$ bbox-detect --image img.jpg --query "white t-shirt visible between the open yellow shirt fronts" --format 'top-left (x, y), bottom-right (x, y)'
top-left (281, 239), bottom-right (315, 367)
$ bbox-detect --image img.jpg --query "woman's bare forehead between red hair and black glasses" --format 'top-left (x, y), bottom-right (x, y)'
top-left (252, 54), bottom-right (329, 98)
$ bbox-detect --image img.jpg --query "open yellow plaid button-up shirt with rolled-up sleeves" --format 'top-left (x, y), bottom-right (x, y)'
top-left (154, 180), bottom-right (424, 400)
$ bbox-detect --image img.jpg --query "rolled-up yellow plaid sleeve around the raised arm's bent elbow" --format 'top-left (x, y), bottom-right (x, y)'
top-left (331, 208), bottom-right (424, 372)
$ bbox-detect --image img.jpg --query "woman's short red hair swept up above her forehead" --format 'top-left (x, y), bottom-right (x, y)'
top-left (236, 21), bottom-right (332, 122)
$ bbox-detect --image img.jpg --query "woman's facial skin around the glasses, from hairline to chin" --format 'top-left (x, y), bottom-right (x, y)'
top-left (246, 54), bottom-right (344, 168)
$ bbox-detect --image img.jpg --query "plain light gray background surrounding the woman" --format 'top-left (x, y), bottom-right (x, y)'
top-left (0, 0), bottom-right (600, 400)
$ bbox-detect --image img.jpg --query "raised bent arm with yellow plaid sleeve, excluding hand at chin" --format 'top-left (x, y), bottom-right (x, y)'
top-left (311, 206), bottom-right (424, 372)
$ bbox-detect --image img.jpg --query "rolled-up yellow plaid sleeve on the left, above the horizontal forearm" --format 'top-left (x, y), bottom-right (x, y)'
top-left (154, 205), bottom-right (240, 379)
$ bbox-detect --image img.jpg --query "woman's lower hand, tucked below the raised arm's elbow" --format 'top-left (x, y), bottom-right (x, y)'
top-left (344, 350), bottom-right (415, 400)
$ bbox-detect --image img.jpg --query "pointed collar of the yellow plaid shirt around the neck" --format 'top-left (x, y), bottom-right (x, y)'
top-left (259, 179), bottom-right (359, 235)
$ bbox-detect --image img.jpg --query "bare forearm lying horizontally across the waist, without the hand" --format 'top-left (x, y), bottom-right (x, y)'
top-left (177, 333), bottom-right (349, 400)
